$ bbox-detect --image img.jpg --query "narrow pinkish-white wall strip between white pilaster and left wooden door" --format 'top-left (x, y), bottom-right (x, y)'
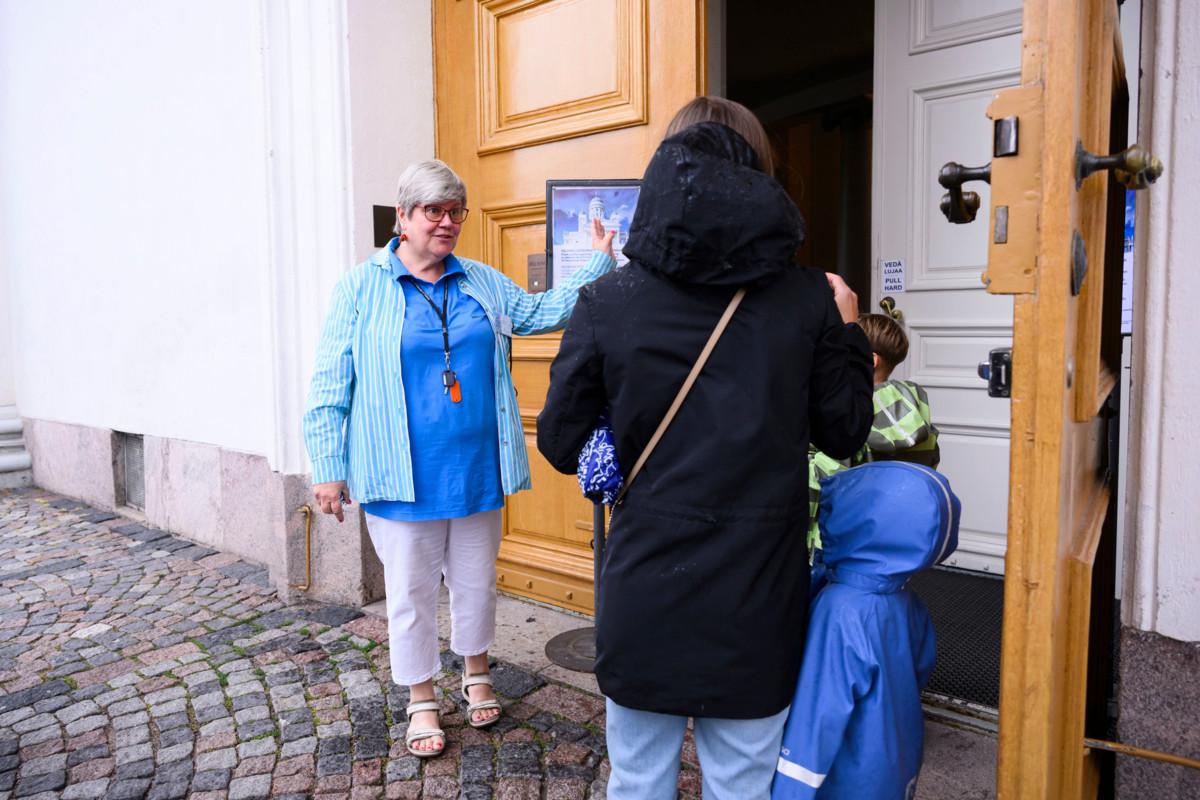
top-left (347, 0), bottom-right (434, 260)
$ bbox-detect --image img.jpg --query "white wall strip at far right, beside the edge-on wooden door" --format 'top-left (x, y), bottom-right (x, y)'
top-left (1122, 0), bottom-right (1200, 642)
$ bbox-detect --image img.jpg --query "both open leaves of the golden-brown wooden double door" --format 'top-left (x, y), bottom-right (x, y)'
top-left (433, 0), bottom-right (1142, 800)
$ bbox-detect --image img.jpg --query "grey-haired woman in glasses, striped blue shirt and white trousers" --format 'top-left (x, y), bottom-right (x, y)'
top-left (304, 161), bottom-right (616, 757)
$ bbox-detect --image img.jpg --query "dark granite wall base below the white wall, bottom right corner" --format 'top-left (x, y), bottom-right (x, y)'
top-left (1116, 627), bottom-right (1200, 800)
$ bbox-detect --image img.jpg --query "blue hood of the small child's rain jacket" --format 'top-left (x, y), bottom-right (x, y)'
top-left (820, 462), bottom-right (961, 593)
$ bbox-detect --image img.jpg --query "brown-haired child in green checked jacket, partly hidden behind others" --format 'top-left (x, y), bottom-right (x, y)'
top-left (809, 314), bottom-right (941, 553)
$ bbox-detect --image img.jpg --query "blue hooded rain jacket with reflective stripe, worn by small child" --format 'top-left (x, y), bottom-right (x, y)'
top-left (772, 462), bottom-right (961, 800)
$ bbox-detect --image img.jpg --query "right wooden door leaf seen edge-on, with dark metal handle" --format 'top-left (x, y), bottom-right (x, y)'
top-left (970, 0), bottom-right (1128, 800)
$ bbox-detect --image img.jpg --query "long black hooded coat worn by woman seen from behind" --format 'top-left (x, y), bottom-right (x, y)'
top-left (538, 122), bottom-right (872, 718)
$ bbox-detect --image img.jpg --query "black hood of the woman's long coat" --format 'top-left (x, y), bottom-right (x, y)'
top-left (624, 122), bottom-right (805, 285)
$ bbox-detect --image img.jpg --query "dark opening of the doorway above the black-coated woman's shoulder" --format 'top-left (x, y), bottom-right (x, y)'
top-left (725, 0), bottom-right (875, 309)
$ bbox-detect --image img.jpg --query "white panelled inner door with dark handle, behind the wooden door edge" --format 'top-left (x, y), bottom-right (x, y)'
top-left (871, 0), bottom-right (1021, 573)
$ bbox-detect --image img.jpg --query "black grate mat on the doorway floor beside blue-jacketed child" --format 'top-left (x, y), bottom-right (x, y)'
top-left (910, 567), bottom-right (1004, 709)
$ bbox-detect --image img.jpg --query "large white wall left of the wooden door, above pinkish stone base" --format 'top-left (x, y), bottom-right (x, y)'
top-left (0, 0), bottom-right (433, 473)
